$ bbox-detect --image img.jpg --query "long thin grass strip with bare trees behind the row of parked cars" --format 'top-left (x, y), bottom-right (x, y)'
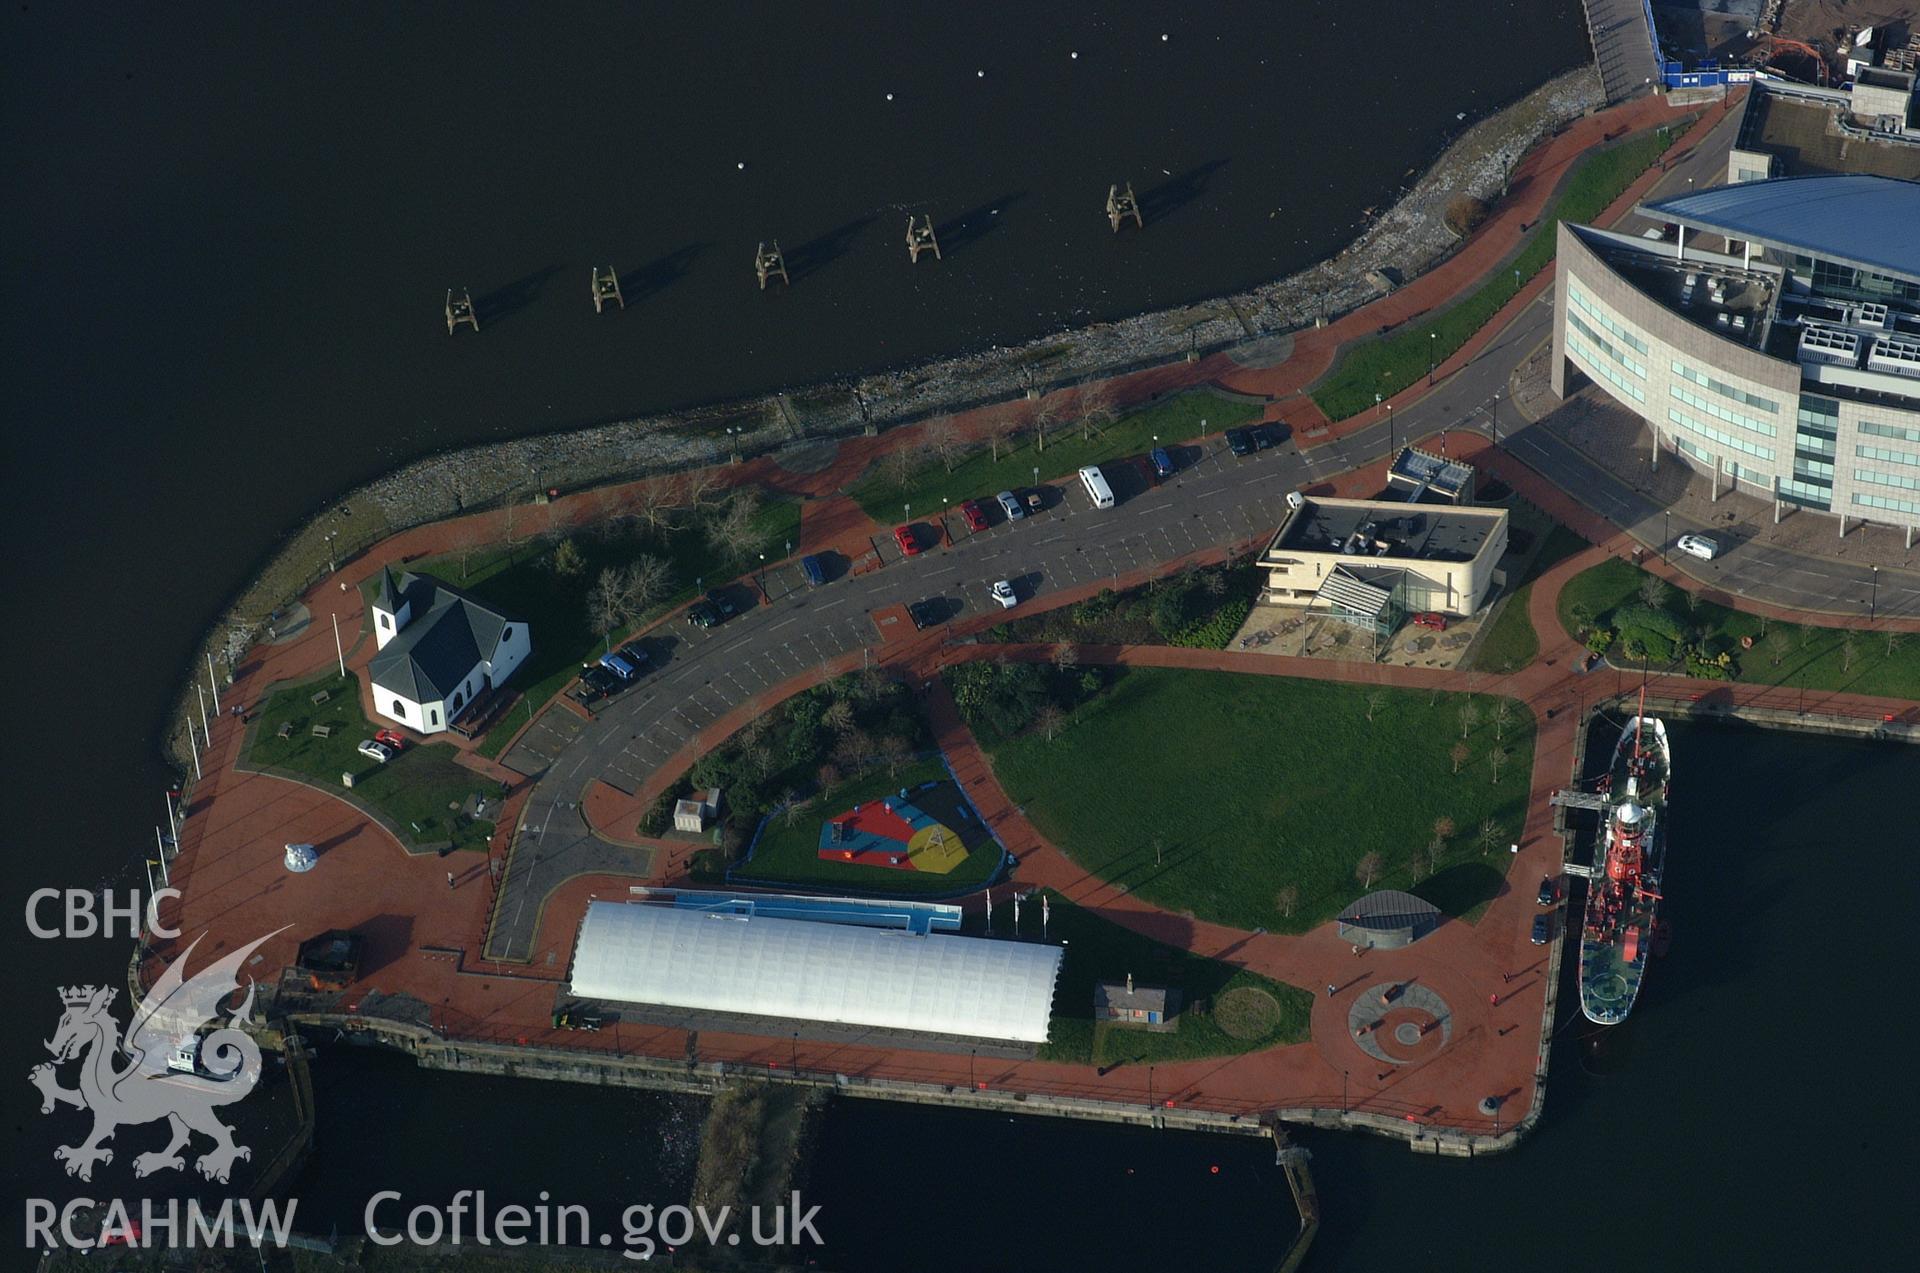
top-left (847, 392), bottom-right (1261, 526)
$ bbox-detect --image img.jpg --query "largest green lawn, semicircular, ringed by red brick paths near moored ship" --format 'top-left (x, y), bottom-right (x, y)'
top-left (993, 668), bottom-right (1534, 931)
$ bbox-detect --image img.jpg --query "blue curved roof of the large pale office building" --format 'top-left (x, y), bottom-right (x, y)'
top-left (1642, 173), bottom-right (1920, 282)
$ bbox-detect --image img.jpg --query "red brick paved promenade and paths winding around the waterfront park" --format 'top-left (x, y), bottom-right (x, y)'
top-left (148, 87), bottom-right (1912, 1131)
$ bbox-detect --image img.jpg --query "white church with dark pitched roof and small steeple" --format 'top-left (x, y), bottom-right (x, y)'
top-left (367, 566), bottom-right (534, 733)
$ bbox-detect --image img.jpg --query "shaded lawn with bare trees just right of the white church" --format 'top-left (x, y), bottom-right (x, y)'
top-left (393, 499), bottom-right (801, 757)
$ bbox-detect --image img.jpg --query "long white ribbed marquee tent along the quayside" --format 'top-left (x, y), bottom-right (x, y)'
top-left (572, 902), bottom-right (1062, 1043)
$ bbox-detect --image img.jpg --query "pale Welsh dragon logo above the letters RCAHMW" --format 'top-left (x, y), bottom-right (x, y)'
top-left (27, 929), bottom-right (286, 1185)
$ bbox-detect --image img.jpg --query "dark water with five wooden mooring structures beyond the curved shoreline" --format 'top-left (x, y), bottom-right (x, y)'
top-left (0, 0), bottom-right (1586, 1213)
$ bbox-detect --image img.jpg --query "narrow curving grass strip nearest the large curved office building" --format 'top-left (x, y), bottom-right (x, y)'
top-left (1309, 129), bottom-right (1674, 420)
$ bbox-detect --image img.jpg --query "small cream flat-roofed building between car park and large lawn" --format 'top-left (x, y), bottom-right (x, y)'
top-left (1260, 495), bottom-right (1507, 618)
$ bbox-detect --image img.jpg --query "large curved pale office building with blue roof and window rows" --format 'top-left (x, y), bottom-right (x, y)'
top-left (1551, 173), bottom-right (1920, 545)
